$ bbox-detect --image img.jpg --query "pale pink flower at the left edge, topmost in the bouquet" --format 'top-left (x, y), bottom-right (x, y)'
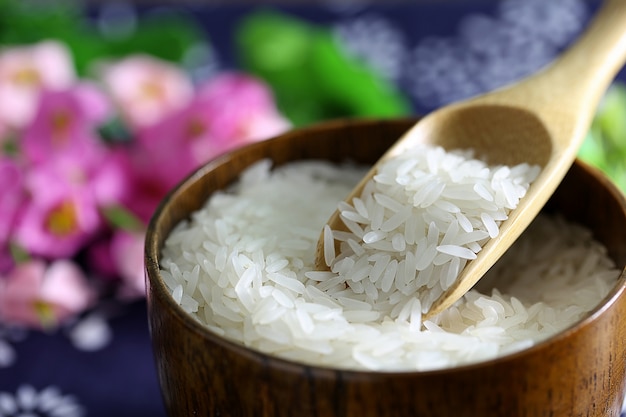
top-left (0, 41), bottom-right (76, 128)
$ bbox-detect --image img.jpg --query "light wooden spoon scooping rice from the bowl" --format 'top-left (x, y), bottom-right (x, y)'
top-left (316, 0), bottom-right (626, 316)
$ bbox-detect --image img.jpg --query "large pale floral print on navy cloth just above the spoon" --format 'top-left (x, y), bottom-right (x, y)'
top-left (407, 0), bottom-right (588, 107)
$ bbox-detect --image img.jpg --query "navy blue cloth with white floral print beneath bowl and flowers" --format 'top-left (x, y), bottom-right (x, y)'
top-left (0, 0), bottom-right (624, 417)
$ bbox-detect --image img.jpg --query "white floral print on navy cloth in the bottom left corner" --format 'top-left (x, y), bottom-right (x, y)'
top-left (0, 385), bottom-right (85, 417)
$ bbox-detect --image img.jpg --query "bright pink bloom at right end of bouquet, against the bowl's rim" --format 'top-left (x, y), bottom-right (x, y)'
top-left (135, 74), bottom-right (289, 190)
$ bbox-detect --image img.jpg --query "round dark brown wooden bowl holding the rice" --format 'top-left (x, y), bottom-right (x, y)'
top-left (145, 119), bottom-right (626, 417)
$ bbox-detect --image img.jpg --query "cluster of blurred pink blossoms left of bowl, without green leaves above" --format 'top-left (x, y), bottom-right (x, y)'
top-left (0, 36), bottom-right (289, 329)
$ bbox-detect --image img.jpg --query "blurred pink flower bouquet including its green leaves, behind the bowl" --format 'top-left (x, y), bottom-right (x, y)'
top-left (0, 0), bottom-right (410, 344)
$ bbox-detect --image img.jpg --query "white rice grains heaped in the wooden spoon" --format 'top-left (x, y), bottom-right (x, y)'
top-left (324, 145), bottom-right (540, 319)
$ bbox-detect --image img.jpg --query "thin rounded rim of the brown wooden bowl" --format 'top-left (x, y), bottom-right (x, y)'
top-left (144, 118), bottom-right (626, 378)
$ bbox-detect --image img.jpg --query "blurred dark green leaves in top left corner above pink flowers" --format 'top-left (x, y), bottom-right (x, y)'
top-left (0, 0), bottom-right (207, 76)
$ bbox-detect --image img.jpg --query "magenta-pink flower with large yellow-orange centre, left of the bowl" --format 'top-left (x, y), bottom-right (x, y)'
top-left (14, 148), bottom-right (131, 258)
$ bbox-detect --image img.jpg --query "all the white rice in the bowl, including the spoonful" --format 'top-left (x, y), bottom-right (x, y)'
top-left (161, 147), bottom-right (620, 371)
